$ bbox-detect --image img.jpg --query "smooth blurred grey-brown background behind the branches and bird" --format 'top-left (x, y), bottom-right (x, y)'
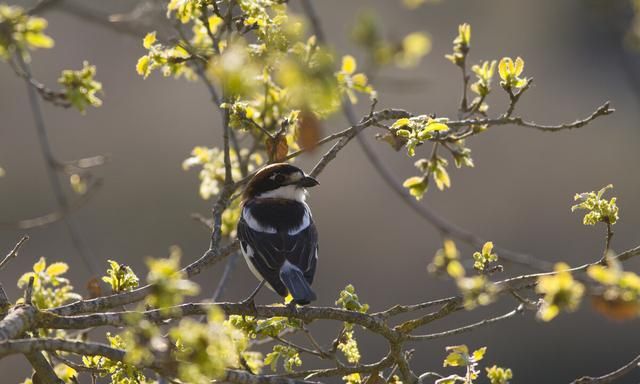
top-left (0, 0), bottom-right (640, 384)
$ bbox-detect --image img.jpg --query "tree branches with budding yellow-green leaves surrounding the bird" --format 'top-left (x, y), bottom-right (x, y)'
top-left (0, 0), bottom-right (640, 384)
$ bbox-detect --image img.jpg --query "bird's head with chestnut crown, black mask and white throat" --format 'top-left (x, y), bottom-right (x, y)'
top-left (244, 163), bottom-right (318, 201)
